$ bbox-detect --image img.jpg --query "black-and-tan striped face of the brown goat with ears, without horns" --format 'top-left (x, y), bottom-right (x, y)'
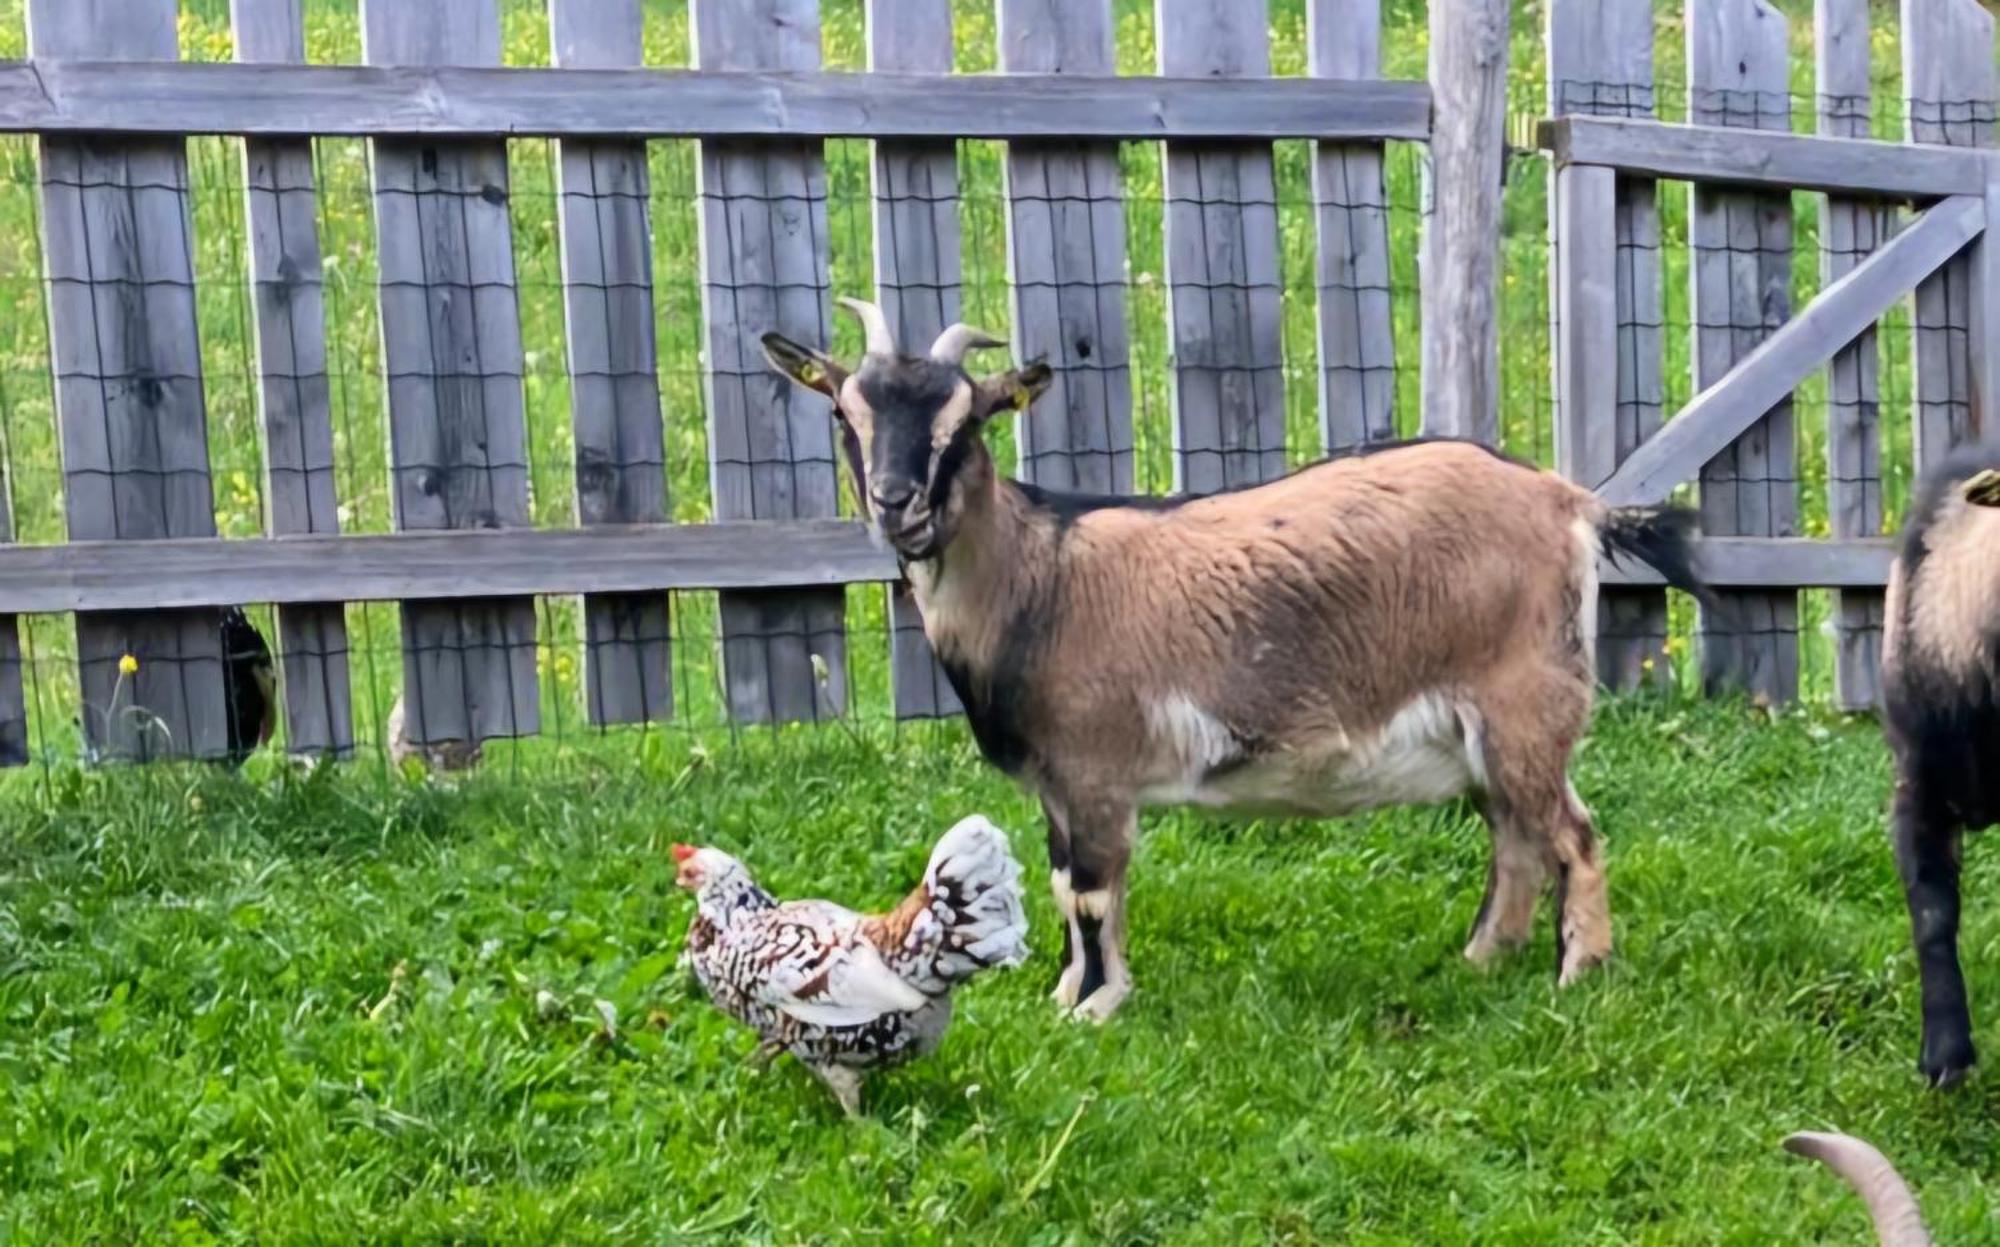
top-left (764, 319), bottom-right (1050, 562)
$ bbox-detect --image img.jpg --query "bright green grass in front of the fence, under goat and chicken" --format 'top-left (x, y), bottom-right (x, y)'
top-left (0, 701), bottom-right (2000, 1245)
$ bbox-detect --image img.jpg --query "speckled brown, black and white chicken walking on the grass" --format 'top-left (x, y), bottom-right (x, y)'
top-left (674, 815), bottom-right (1028, 1115)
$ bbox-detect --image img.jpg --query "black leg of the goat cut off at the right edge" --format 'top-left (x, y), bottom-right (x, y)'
top-left (1896, 781), bottom-right (1978, 1087)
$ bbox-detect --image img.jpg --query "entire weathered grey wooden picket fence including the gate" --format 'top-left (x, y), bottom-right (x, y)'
top-left (0, 0), bottom-right (2000, 761)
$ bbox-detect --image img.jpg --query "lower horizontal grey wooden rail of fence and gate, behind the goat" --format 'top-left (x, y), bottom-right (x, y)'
top-left (0, 520), bottom-right (1890, 616)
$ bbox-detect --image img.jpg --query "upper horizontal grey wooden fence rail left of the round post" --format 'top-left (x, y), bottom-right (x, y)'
top-left (0, 60), bottom-right (1430, 142)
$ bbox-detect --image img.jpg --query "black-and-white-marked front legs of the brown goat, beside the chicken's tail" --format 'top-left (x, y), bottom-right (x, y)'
top-left (1056, 799), bottom-right (1138, 1021)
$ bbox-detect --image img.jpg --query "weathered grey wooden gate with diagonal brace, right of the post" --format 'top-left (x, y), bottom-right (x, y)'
top-left (1542, 0), bottom-right (2000, 707)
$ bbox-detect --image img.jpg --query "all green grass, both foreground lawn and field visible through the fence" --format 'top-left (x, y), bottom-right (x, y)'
top-left (0, 9), bottom-right (1976, 1243)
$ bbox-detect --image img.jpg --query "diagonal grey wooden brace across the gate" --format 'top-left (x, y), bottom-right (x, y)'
top-left (1598, 194), bottom-right (1986, 506)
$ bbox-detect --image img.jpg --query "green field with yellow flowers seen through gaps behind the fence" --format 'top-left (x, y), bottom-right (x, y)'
top-left (0, 0), bottom-right (1944, 757)
